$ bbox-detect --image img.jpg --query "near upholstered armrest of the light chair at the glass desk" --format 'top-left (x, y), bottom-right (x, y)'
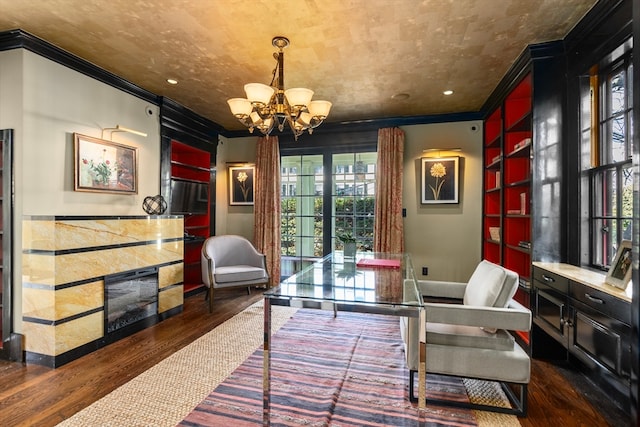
top-left (424, 303), bottom-right (531, 331)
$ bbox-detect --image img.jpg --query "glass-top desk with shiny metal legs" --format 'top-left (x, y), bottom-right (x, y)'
top-left (263, 252), bottom-right (426, 425)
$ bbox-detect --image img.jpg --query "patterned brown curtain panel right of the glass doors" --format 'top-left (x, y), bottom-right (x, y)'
top-left (373, 128), bottom-right (404, 253)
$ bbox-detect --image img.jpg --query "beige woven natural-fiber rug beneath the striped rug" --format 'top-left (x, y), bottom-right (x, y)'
top-left (58, 301), bottom-right (520, 427)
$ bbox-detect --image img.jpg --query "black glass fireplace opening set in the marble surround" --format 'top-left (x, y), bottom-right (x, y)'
top-left (104, 267), bottom-right (158, 335)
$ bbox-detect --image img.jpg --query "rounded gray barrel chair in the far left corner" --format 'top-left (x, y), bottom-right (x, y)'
top-left (201, 235), bottom-right (269, 312)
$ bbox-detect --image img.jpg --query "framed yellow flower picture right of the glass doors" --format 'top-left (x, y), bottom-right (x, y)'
top-left (421, 157), bottom-right (460, 205)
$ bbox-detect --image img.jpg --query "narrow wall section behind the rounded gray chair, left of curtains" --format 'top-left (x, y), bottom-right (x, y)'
top-left (215, 136), bottom-right (258, 242)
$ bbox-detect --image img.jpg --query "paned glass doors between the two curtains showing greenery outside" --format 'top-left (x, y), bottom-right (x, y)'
top-left (280, 150), bottom-right (377, 275)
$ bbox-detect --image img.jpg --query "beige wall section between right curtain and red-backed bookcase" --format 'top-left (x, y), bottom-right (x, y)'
top-left (402, 121), bottom-right (483, 282)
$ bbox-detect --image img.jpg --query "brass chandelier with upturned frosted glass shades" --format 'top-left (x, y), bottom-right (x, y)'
top-left (227, 37), bottom-right (331, 141)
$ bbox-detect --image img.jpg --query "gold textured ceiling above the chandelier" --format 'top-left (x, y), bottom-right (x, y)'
top-left (0, 0), bottom-right (596, 130)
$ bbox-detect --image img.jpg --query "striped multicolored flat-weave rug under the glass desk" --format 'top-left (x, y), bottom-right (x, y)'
top-left (180, 310), bottom-right (519, 427)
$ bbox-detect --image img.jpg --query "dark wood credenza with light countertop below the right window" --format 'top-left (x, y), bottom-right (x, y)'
top-left (531, 262), bottom-right (632, 409)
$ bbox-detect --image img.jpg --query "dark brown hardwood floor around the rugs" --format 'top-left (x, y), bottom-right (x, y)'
top-left (0, 289), bottom-right (628, 427)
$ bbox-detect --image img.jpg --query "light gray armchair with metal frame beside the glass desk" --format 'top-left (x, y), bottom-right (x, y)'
top-left (400, 261), bottom-right (531, 416)
